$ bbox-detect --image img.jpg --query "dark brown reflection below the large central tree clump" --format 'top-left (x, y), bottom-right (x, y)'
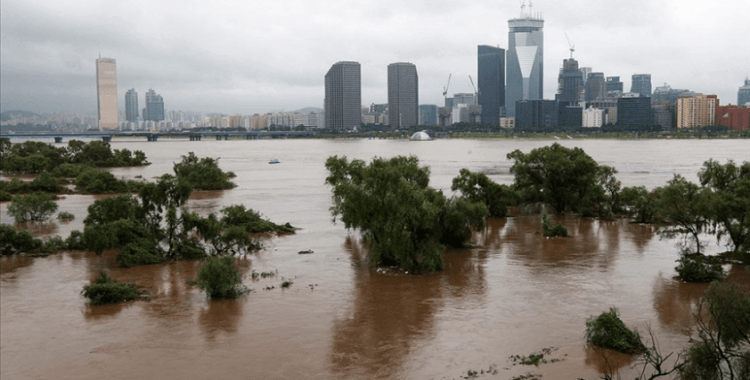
top-left (330, 237), bottom-right (487, 378)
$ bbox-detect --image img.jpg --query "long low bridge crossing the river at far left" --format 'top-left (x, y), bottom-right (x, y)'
top-left (0, 131), bottom-right (315, 142)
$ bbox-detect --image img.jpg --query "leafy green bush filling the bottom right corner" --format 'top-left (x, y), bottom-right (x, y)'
top-left (680, 282), bottom-right (750, 380)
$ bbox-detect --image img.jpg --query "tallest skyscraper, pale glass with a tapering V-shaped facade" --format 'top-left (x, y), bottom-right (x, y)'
top-left (505, 7), bottom-right (544, 116)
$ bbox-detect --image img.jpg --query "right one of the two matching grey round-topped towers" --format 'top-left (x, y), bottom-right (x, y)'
top-left (388, 62), bottom-right (419, 127)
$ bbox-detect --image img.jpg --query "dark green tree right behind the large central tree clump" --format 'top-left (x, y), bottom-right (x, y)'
top-left (451, 169), bottom-right (518, 218)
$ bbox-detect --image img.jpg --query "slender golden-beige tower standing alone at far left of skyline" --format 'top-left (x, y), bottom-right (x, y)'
top-left (96, 57), bottom-right (119, 130)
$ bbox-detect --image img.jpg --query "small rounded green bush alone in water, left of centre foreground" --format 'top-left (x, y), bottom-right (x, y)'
top-left (196, 256), bottom-right (247, 298)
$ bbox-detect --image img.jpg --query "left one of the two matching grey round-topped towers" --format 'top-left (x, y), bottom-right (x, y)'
top-left (324, 62), bottom-right (362, 130)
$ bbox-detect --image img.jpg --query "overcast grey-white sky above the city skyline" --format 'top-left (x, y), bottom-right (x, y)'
top-left (0, 0), bottom-right (750, 114)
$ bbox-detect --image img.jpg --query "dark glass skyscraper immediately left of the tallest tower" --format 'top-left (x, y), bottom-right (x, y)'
top-left (477, 45), bottom-right (505, 124)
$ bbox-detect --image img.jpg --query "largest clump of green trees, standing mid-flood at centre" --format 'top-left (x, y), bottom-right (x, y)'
top-left (326, 156), bottom-right (487, 272)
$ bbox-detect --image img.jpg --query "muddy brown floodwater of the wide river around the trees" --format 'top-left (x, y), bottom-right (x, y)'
top-left (0, 139), bottom-right (750, 380)
